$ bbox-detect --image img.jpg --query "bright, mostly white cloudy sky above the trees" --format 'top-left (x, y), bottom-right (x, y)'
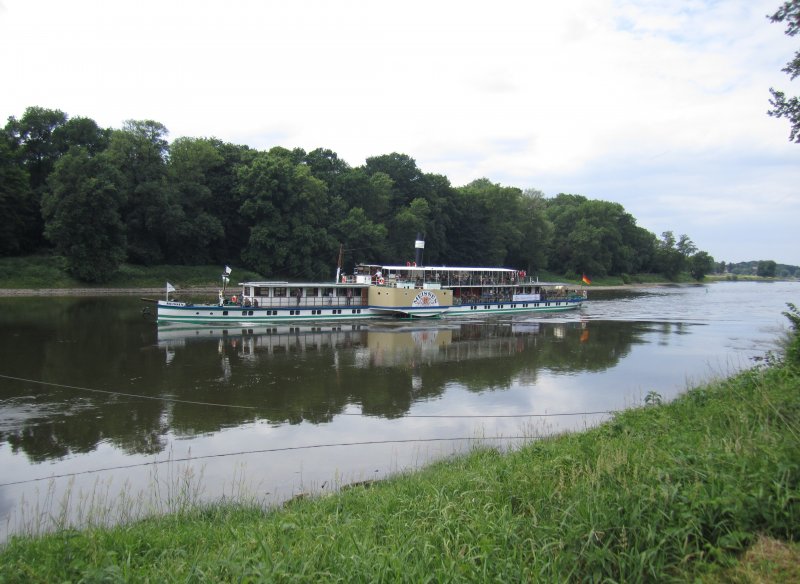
top-left (0, 0), bottom-right (800, 265)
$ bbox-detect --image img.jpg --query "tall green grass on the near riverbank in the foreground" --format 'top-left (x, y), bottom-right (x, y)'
top-left (0, 305), bottom-right (800, 582)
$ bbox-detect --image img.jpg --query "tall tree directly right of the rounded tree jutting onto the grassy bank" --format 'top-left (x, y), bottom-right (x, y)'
top-left (108, 120), bottom-right (172, 265)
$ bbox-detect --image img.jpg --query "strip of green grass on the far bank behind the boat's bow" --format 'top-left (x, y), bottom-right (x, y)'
top-left (0, 255), bottom-right (263, 289)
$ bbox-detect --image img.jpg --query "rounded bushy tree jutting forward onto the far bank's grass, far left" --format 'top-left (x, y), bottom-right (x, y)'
top-left (42, 147), bottom-right (125, 282)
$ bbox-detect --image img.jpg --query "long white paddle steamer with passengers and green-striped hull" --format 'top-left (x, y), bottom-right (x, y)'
top-left (157, 241), bottom-right (586, 325)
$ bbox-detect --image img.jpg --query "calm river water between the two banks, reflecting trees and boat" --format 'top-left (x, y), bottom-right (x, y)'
top-left (0, 282), bottom-right (800, 538)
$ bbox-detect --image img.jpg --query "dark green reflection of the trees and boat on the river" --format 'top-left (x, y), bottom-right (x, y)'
top-left (0, 312), bottom-right (650, 462)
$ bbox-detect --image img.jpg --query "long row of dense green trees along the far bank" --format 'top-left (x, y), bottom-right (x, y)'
top-left (0, 107), bottom-right (717, 283)
